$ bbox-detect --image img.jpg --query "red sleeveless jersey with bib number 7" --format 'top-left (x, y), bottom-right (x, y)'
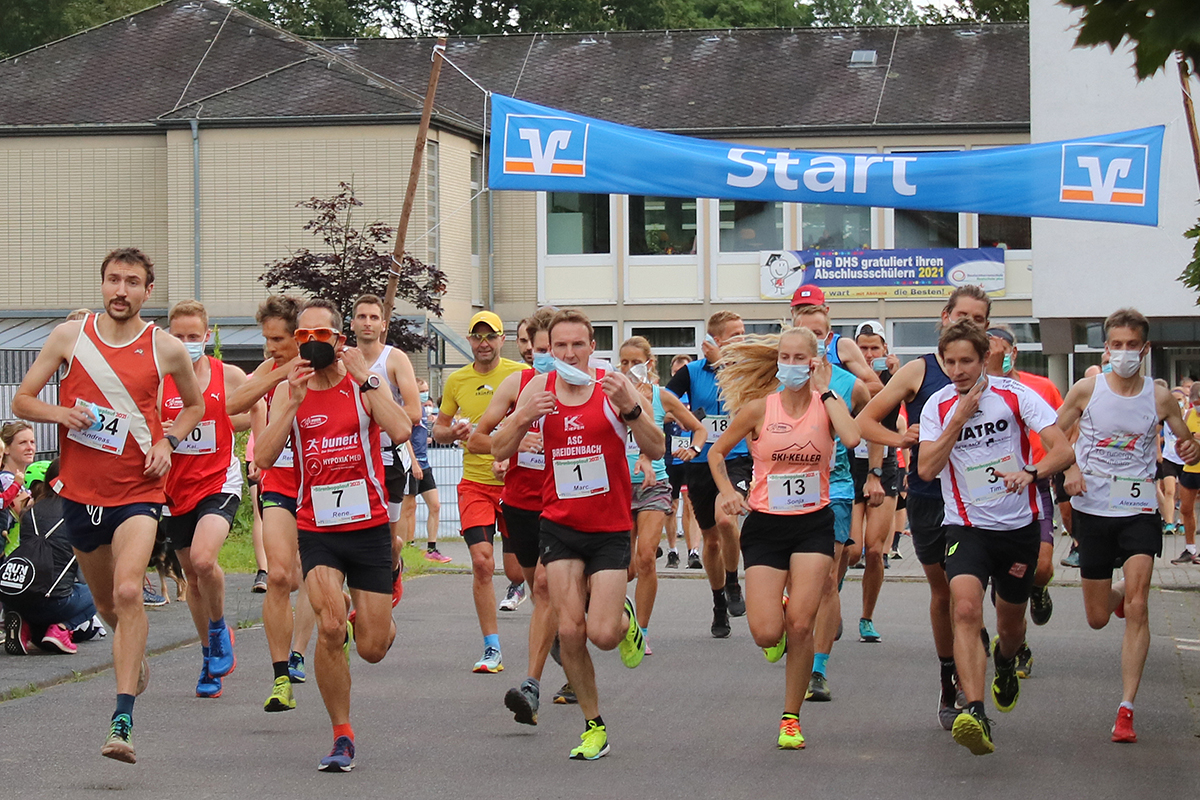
top-left (292, 374), bottom-right (388, 533)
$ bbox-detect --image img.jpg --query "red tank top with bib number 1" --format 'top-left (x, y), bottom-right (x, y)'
top-left (541, 369), bottom-right (634, 533)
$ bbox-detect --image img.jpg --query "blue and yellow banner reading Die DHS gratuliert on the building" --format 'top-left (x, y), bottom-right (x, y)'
top-left (758, 247), bottom-right (1004, 300)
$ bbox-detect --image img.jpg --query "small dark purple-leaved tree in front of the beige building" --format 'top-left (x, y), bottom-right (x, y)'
top-left (259, 182), bottom-right (446, 353)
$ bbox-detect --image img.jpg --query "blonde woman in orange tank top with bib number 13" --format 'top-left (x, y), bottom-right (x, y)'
top-left (708, 327), bottom-right (859, 750)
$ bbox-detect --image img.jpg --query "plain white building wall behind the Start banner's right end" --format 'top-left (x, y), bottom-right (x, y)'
top-left (1030, 0), bottom-right (1200, 318)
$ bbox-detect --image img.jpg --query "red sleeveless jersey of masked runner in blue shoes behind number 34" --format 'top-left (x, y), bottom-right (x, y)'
top-left (162, 356), bottom-right (242, 517)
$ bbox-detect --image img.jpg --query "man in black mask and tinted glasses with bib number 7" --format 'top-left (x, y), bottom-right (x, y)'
top-left (254, 299), bottom-right (412, 772)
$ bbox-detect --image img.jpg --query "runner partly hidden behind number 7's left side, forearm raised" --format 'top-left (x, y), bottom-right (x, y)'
top-left (227, 295), bottom-right (313, 712)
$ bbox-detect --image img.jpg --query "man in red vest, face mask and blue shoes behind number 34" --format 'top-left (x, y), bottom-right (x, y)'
top-left (160, 300), bottom-right (250, 697)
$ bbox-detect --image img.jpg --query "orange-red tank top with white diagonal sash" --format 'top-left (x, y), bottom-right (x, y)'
top-left (59, 314), bottom-right (166, 506)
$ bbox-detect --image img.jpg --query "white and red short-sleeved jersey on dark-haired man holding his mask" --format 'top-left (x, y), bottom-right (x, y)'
top-left (920, 377), bottom-right (1058, 530)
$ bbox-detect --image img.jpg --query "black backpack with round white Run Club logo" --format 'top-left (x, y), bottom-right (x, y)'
top-left (0, 495), bottom-right (74, 600)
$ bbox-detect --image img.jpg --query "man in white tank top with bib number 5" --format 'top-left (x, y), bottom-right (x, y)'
top-left (1058, 308), bottom-right (1200, 742)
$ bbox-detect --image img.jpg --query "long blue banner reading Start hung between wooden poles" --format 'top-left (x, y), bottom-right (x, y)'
top-left (488, 95), bottom-right (1164, 225)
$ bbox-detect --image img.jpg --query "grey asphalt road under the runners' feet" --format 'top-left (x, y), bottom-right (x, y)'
top-left (0, 576), bottom-right (1200, 800)
